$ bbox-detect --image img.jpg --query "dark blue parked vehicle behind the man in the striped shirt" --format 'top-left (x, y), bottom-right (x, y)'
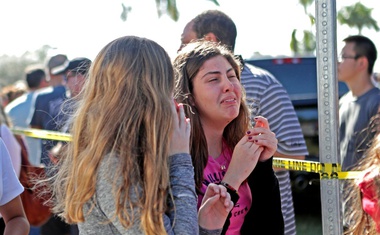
top-left (245, 57), bottom-right (348, 193)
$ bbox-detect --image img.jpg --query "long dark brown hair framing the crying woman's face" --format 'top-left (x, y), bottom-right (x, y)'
top-left (173, 40), bottom-right (250, 193)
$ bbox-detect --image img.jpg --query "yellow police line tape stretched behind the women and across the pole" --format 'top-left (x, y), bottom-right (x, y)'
top-left (12, 128), bottom-right (361, 179)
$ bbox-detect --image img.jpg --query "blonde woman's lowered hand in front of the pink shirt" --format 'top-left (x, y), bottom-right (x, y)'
top-left (198, 183), bottom-right (234, 230)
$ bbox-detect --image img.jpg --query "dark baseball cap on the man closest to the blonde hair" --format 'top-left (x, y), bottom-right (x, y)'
top-left (52, 57), bottom-right (91, 75)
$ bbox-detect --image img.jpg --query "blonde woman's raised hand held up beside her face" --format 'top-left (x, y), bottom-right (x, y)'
top-left (169, 100), bottom-right (191, 155)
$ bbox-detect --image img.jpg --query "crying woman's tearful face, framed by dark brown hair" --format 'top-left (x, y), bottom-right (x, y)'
top-left (193, 55), bottom-right (241, 128)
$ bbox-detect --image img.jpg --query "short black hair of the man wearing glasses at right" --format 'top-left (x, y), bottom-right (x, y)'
top-left (343, 35), bottom-right (377, 74)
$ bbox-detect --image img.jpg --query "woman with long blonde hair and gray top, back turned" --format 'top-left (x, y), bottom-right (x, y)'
top-left (52, 36), bottom-right (232, 234)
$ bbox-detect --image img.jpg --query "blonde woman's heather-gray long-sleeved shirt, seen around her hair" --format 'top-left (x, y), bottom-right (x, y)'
top-left (78, 153), bottom-right (221, 235)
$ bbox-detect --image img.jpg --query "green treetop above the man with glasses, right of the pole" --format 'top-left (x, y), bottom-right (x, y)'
top-left (337, 2), bottom-right (379, 34)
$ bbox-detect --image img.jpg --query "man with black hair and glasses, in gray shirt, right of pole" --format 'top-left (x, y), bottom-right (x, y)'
top-left (338, 35), bottom-right (380, 171)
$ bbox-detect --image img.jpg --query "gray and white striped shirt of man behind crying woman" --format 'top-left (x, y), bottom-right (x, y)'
top-left (241, 63), bottom-right (308, 235)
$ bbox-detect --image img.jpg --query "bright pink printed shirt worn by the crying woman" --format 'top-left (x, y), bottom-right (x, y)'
top-left (198, 148), bottom-right (252, 235)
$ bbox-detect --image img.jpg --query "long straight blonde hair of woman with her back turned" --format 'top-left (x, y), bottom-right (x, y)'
top-left (53, 36), bottom-right (174, 234)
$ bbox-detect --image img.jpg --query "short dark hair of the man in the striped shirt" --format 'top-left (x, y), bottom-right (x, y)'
top-left (192, 10), bottom-right (237, 51)
